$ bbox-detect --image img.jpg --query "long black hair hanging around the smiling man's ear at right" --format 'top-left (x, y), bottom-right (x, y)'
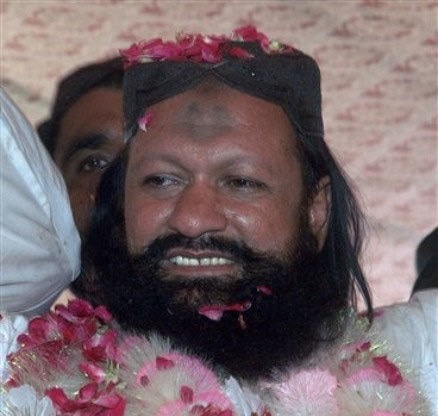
top-left (297, 133), bottom-right (372, 321)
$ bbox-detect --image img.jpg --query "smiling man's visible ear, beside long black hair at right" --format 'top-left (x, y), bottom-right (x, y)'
top-left (308, 176), bottom-right (331, 251)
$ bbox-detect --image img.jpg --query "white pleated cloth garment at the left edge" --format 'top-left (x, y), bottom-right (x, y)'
top-left (0, 88), bottom-right (80, 316)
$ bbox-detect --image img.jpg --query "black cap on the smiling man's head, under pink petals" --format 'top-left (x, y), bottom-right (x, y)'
top-left (122, 30), bottom-right (324, 139)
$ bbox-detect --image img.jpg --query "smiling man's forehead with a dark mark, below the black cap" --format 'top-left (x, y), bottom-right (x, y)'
top-left (128, 82), bottom-right (295, 152)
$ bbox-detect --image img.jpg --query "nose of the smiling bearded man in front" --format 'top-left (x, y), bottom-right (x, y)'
top-left (168, 185), bottom-right (227, 238)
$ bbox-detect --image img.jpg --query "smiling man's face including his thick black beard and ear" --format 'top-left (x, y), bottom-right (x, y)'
top-left (90, 85), bottom-right (338, 378)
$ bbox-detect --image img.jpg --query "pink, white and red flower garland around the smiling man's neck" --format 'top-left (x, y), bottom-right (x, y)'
top-left (0, 299), bottom-right (428, 416)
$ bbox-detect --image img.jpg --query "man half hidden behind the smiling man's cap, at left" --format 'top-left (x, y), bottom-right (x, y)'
top-left (37, 58), bottom-right (124, 238)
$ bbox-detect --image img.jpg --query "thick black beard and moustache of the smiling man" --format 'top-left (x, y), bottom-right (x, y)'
top-left (90, 227), bottom-right (346, 380)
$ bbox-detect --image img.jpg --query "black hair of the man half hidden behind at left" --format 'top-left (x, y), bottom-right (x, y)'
top-left (37, 57), bottom-right (124, 156)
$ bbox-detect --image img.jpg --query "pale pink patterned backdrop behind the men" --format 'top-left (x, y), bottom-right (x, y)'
top-left (0, 0), bottom-right (438, 305)
